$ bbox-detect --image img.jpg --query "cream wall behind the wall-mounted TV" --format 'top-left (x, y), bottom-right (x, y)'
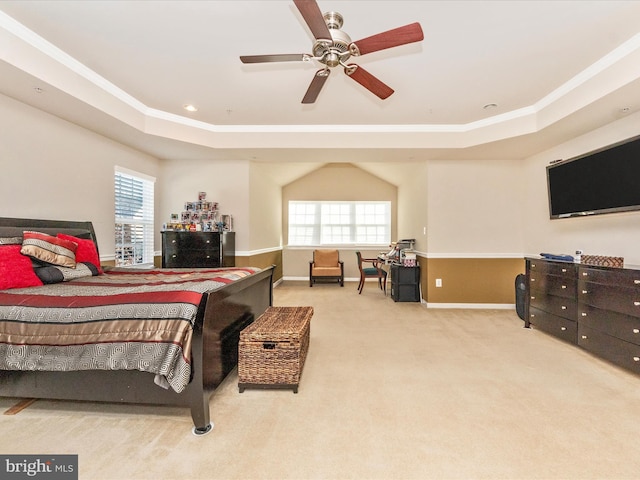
top-left (524, 113), bottom-right (640, 265)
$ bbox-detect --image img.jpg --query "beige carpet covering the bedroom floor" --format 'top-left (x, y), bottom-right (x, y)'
top-left (0, 282), bottom-right (640, 480)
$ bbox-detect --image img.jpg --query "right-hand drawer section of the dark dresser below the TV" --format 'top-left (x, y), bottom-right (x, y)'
top-left (578, 265), bottom-right (640, 373)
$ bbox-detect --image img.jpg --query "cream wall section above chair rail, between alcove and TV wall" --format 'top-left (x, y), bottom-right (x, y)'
top-left (423, 160), bottom-right (524, 257)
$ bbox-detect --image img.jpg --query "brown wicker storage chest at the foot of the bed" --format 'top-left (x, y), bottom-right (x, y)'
top-left (238, 307), bottom-right (313, 393)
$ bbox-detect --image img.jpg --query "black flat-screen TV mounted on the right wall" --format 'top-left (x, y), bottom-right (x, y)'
top-left (547, 136), bottom-right (640, 219)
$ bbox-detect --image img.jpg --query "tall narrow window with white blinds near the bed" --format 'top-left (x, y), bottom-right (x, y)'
top-left (115, 167), bottom-right (155, 267)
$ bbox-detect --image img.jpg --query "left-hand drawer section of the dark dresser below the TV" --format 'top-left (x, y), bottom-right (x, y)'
top-left (525, 258), bottom-right (578, 344)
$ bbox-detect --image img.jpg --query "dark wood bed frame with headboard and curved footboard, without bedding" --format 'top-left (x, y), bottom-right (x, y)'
top-left (0, 218), bottom-right (274, 435)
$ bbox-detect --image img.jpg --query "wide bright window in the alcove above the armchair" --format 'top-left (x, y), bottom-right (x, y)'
top-left (289, 201), bottom-right (391, 245)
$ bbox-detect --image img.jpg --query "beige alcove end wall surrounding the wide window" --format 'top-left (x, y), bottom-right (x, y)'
top-left (282, 163), bottom-right (397, 279)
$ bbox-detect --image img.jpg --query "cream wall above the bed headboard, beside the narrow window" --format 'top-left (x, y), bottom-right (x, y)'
top-left (0, 95), bottom-right (160, 259)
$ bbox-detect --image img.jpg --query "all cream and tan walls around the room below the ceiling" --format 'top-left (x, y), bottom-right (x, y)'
top-left (5, 87), bottom-right (640, 304)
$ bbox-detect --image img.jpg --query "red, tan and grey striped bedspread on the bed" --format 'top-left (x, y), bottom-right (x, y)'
top-left (0, 267), bottom-right (260, 392)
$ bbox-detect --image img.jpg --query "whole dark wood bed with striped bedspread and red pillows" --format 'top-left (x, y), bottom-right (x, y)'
top-left (0, 218), bottom-right (274, 435)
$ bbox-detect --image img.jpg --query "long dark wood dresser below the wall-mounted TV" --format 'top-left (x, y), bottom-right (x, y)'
top-left (525, 258), bottom-right (640, 373)
